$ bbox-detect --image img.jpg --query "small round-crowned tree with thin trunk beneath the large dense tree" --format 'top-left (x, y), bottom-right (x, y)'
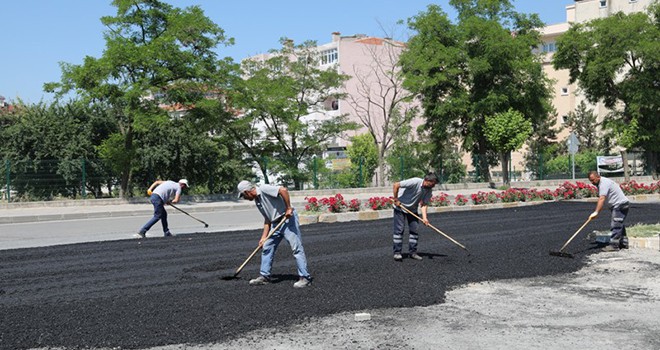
top-left (484, 109), bottom-right (533, 185)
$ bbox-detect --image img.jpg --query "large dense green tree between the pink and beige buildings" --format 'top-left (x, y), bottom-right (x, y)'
top-left (400, 0), bottom-right (553, 181)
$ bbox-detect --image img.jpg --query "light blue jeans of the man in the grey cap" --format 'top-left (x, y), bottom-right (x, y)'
top-left (260, 210), bottom-right (310, 278)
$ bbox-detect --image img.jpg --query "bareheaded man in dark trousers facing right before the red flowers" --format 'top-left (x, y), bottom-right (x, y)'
top-left (392, 173), bottom-right (438, 261)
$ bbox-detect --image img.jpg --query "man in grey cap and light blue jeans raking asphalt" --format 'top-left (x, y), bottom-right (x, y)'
top-left (237, 181), bottom-right (312, 288)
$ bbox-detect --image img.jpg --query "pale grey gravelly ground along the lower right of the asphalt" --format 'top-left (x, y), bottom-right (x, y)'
top-left (179, 249), bottom-right (660, 350)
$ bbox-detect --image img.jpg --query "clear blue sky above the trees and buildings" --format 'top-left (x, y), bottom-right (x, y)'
top-left (0, 0), bottom-right (574, 103)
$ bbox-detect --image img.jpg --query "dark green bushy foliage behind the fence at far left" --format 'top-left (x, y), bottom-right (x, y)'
top-left (0, 101), bottom-right (115, 200)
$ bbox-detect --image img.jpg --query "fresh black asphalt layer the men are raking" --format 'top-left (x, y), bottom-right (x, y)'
top-left (0, 202), bottom-right (660, 349)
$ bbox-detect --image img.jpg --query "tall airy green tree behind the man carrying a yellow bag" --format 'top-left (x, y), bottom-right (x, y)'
top-left (44, 0), bottom-right (233, 196)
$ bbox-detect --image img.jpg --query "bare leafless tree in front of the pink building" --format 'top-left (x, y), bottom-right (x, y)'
top-left (346, 39), bottom-right (417, 186)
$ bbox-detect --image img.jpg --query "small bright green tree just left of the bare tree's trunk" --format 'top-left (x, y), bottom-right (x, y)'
top-left (346, 134), bottom-right (378, 187)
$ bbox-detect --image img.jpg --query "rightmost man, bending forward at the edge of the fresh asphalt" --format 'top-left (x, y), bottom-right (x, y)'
top-left (589, 171), bottom-right (630, 252)
